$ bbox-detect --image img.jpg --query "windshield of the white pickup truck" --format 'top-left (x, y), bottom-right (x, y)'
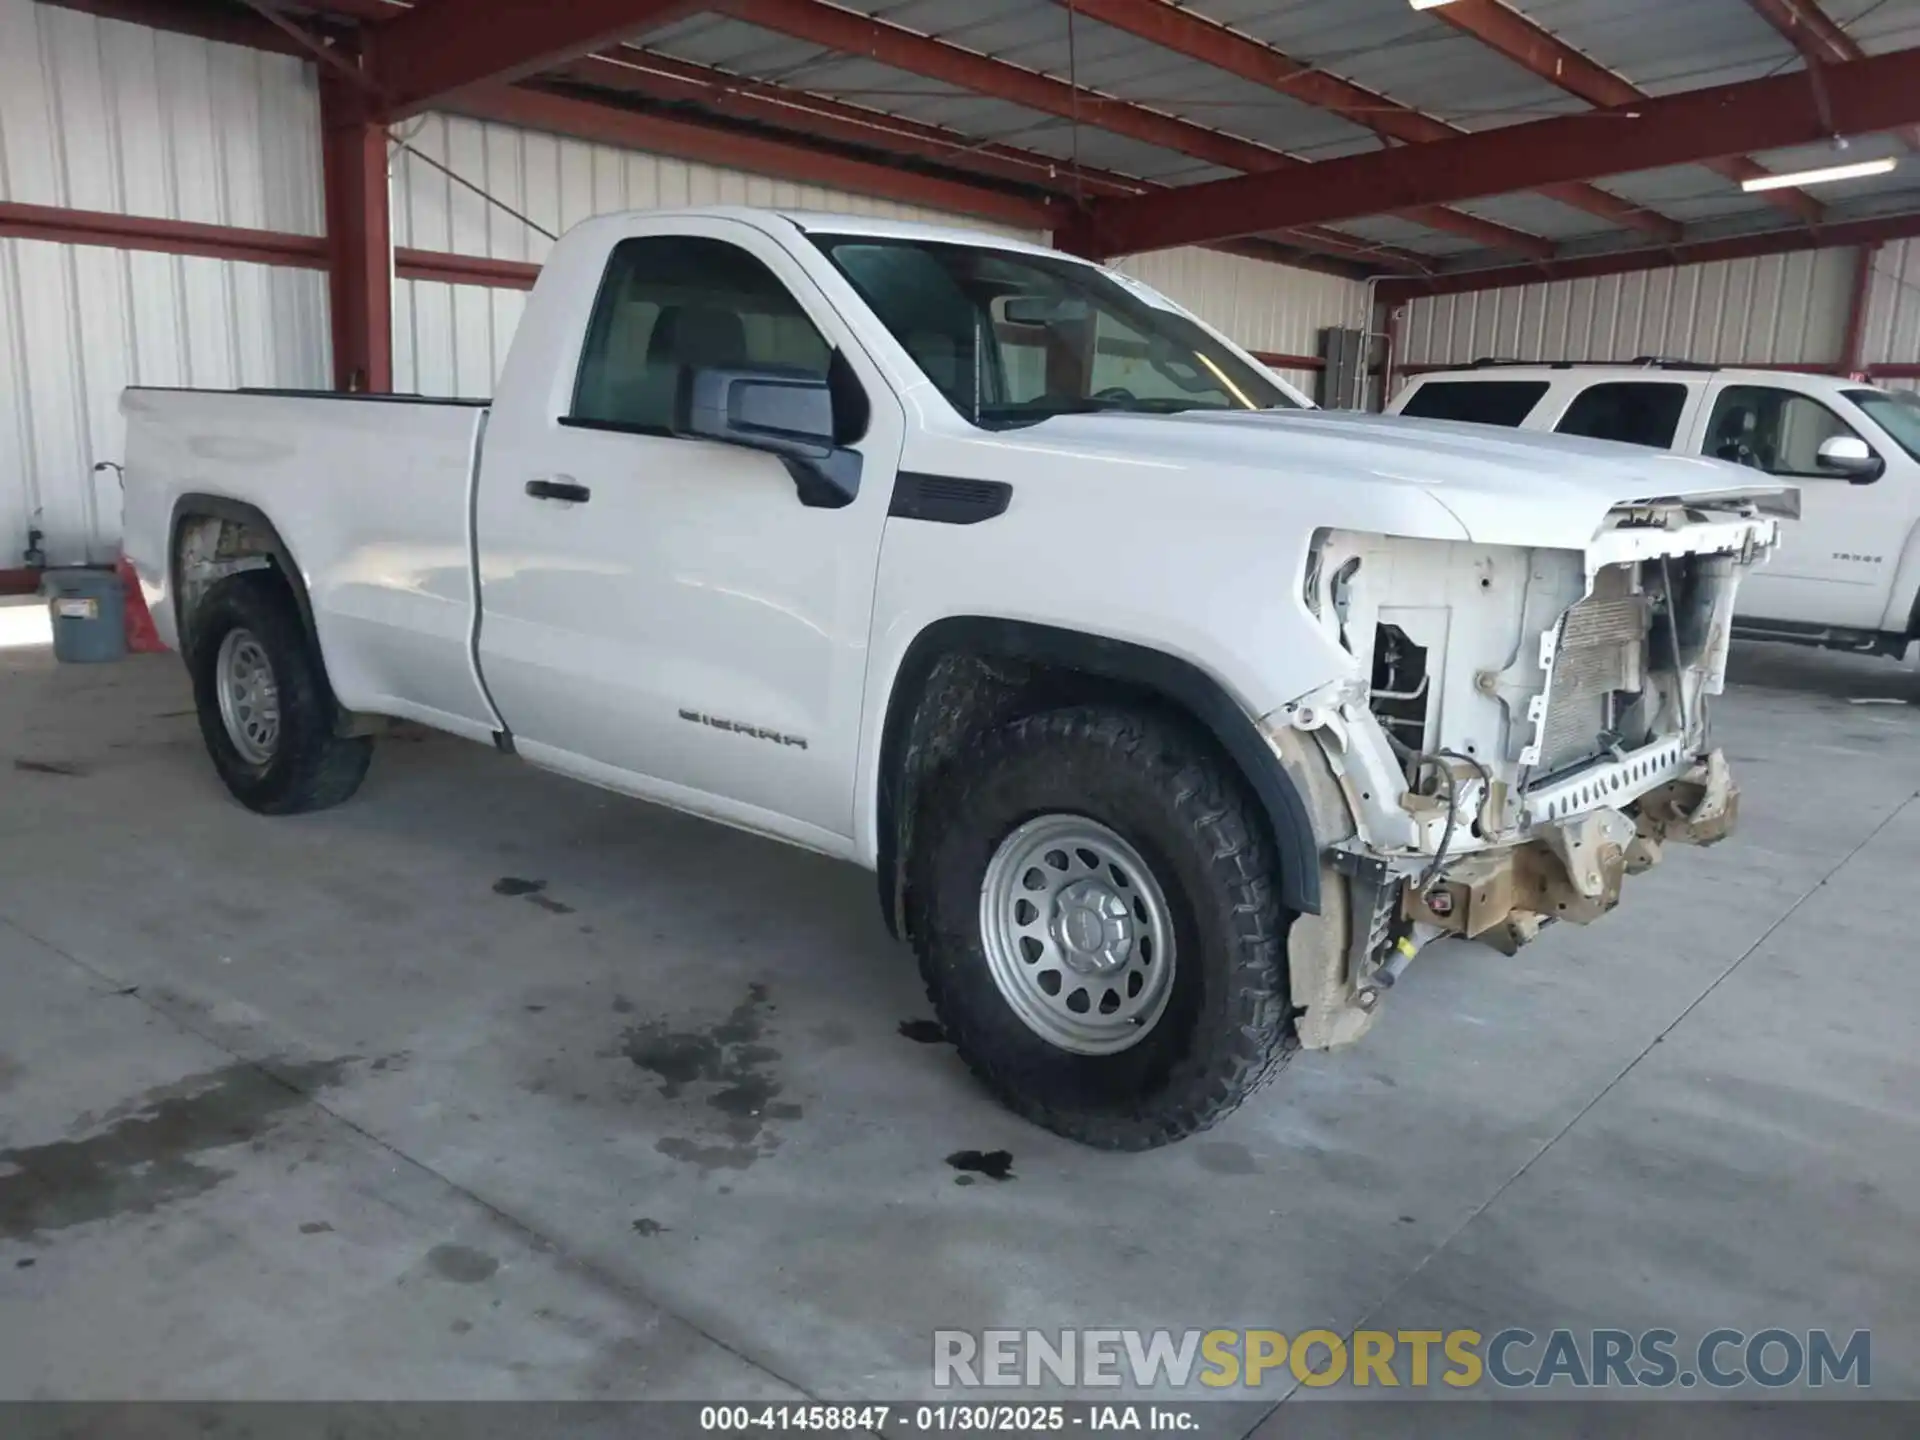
top-left (814, 234), bottom-right (1296, 428)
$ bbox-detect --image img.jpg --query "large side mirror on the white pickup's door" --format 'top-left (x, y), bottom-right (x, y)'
top-left (674, 369), bottom-right (860, 509)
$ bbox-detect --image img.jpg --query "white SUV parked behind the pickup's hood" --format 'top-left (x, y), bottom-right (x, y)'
top-left (1388, 359), bottom-right (1920, 657)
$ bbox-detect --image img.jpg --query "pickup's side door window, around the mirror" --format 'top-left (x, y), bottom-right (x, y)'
top-left (568, 236), bottom-right (833, 436)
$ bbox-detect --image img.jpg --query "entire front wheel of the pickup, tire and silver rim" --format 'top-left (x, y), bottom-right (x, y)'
top-left (910, 708), bottom-right (1292, 1150)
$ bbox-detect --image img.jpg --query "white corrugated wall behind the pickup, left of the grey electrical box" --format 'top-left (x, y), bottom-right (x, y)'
top-left (0, 0), bottom-right (1363, 568)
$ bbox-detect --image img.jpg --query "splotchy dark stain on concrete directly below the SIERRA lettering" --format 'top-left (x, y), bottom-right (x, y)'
top-left (620, 983), bottom-right (801, 1173)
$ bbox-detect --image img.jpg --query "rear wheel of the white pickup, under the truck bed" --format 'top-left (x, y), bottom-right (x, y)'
top-left (188, 570), bottom-right (372, 814)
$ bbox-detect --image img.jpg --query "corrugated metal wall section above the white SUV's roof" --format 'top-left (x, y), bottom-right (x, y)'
top-left (1396, 250), bottom-right (1855, 384)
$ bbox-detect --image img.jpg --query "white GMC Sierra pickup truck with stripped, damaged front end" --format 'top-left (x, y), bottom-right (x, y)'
top-left (123, 209), bottom-right (1791, 1148)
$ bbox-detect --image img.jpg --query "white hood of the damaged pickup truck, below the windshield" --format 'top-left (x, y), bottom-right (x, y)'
top-left (1004, 409), bottom-right (1799, 549)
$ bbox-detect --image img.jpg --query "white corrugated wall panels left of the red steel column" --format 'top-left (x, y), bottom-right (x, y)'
top-left (0, 0), bottom-right (328, 568)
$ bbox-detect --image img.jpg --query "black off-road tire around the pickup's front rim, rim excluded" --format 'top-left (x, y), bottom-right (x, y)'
top-left (908, 708), bottom-right (1296, 1150)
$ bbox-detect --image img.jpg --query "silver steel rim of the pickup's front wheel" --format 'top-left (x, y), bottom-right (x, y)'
top-left (979, 814), bottom-right (1175, 1054)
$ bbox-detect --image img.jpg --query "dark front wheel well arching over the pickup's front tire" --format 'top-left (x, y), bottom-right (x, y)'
top-left (876, 618), bottom-right (1319, 937)
